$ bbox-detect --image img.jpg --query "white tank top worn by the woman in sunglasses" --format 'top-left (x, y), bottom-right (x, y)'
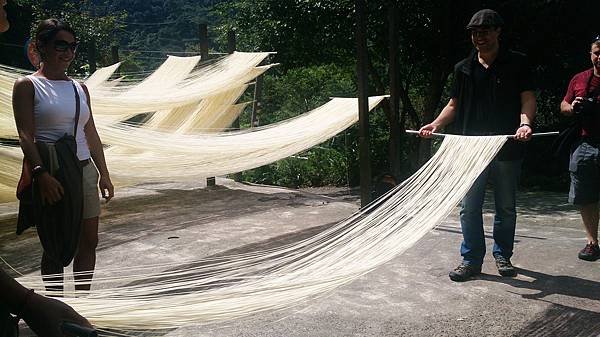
top-left (27, 75), bottom-right (90, 160)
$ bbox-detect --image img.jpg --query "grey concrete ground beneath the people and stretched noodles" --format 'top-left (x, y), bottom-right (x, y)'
top-left (0, 180), bottom-right (600, 337)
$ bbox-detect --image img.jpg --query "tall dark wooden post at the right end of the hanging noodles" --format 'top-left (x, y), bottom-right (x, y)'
top-left (355, 0), bottom-right (371, 207)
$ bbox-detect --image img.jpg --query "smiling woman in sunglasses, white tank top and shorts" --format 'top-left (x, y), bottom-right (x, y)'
top-left (13, 19), bottom-right (114, 290)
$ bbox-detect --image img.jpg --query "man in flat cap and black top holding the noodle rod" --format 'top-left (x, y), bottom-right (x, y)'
top-left (419, 9), bottom-right (536, 281)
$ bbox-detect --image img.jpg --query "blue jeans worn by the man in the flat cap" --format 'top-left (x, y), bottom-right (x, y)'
top-left (460, 159), bottom-right (523, 266)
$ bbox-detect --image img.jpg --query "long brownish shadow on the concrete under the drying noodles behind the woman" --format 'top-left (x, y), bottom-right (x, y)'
top-left (0, 186), bottom-right (338, 276)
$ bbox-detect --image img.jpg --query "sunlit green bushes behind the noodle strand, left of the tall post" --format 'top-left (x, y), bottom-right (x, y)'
top-left (240, 64), bottom-right (356, 187)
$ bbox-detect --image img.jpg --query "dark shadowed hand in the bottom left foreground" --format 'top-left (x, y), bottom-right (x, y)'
top-left (23, 294), bottom-right (92, 337)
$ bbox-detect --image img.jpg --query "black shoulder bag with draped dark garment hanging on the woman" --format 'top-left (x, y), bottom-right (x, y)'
top-left (17, 83), bottom-right (83, 267)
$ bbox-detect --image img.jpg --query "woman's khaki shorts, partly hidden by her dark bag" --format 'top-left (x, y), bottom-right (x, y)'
top-left (48, 144), bottom-right (100, 219)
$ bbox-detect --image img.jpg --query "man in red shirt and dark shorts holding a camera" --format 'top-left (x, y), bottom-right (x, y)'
top-left (560, 35), bottom-right (600, 261)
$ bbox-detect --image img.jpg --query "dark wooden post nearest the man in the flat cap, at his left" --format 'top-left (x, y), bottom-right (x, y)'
top-left (388, 0), bottom-right (404, 180)
